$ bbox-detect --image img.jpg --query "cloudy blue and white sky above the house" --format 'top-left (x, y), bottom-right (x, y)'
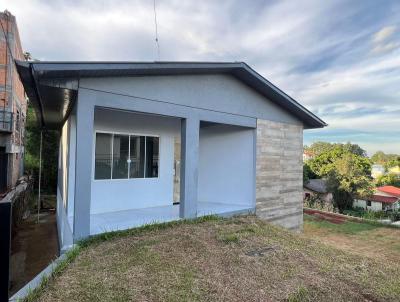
top-left (0, 0), bottom-right (400, 155)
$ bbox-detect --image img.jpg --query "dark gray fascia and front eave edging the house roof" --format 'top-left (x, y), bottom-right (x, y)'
top-left (16, 61), bottom-right (327, 129)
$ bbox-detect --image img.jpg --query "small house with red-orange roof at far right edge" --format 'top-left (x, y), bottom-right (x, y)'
top-left (353, 186), bottom-right (400, 211)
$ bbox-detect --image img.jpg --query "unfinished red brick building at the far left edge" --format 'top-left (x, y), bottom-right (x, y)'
top-left (0, 11), bottom-right (27, 194)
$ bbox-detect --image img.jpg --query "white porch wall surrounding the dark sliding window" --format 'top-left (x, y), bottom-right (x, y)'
top-left (90, 109), bottom-right (180, 214)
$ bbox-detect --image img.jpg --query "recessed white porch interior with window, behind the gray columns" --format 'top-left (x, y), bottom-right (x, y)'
top-left (83, 108), bottom-right (255, 235)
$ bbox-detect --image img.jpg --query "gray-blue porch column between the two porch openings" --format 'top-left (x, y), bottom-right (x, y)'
top-left (179, 118), bottom-right (200, 218)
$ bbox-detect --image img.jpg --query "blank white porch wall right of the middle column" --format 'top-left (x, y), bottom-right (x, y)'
top-left (198, 125), bottom-right (255, 208)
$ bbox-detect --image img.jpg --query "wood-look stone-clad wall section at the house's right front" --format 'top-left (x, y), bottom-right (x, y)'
top-left (256, 120), bottom-right (303, 230)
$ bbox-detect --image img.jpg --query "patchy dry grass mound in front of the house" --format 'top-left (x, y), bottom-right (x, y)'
top-left (26, 216), bottom-right (400, 301)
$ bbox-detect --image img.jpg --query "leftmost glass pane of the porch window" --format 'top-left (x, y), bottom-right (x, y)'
top-left (94, 133), bottom-right (112, 179)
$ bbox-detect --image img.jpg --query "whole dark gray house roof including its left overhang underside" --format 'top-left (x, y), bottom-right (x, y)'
top-left (16, 61), bottom-right (327, 129)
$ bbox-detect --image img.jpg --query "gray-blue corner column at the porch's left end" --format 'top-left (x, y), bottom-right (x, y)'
top-left (74, 90), bottom-right (94, 242)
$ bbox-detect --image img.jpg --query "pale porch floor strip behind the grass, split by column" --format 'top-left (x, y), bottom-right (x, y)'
top-left (90, 202), bottom-right (254, 235)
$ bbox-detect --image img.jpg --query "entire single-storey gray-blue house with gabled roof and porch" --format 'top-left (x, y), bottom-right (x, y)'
top-left (17, 62), bottom-right (326, 249)
